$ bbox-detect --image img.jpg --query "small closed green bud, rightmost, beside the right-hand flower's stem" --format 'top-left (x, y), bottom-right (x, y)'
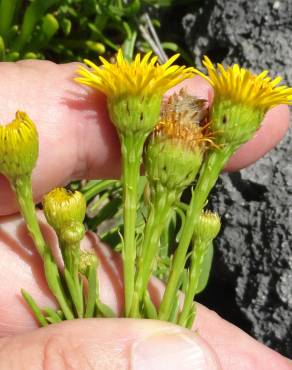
top-left (194, 211), bottom-right (221, 245)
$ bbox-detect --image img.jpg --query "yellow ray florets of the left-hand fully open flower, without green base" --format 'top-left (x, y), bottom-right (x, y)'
top-left (76, 49), bottom-right (194, 98)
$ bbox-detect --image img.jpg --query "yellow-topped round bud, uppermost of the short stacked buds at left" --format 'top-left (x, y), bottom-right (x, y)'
top-left (43, 188), bottom-right (86, 234)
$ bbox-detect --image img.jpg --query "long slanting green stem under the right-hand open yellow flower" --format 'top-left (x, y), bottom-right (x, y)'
top-left (158, 146), bottom-right (235, 321)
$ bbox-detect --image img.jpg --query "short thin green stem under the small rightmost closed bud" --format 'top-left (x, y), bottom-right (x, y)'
top-left (178, 241), bottom-right (207, 326)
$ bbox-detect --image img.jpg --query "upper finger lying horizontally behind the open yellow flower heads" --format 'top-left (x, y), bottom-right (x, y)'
top-left (0, 61), bottom-right (288, 215)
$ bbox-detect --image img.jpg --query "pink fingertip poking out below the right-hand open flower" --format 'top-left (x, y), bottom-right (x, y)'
top-left (225, 104), bottom-right (290, 171)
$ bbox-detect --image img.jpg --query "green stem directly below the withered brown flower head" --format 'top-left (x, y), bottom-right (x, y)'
top-left (131, 185), bottom-right (177, 317)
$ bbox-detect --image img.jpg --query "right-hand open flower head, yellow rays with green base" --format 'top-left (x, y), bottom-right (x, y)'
top-left (196, 56), bottom-right (292, 150)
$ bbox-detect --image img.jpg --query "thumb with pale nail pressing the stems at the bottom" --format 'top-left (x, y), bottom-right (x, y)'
top-left (0, 319), bottom-right (221, 370)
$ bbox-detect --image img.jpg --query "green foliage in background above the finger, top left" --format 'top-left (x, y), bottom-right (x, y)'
top-left (0, 0), bottom-right (189, 62)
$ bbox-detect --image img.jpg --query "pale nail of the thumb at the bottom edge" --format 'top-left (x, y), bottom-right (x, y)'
top-left (131, 329), bottom-right (220, 370)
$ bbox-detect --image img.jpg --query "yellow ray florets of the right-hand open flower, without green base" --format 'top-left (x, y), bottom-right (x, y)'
top-left (195, 56), bottom-right (292, 110)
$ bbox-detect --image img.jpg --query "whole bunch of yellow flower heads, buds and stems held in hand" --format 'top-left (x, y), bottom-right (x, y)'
top-left (0, 50), bottom-right (292, 325)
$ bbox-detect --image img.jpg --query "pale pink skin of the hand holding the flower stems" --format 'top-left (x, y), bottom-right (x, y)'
top-left (0, 61), bottom-right (292, 370)
